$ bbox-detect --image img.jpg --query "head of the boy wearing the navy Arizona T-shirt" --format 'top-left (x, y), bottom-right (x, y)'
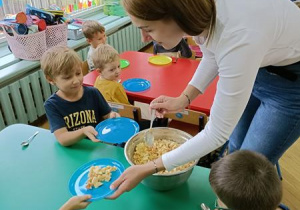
top-left (41, 46), bottom-right (83, 94)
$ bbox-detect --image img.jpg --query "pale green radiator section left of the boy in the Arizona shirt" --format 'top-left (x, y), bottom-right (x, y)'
top-left (0, 70), bottom-right (57, 130)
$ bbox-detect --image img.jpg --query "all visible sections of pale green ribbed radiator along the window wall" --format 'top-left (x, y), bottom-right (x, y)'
top-left (0, 24), bottom-right (147, 130)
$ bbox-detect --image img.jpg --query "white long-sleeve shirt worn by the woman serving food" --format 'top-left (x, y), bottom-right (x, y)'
top-left (162, 0), bottom-right (300, 170)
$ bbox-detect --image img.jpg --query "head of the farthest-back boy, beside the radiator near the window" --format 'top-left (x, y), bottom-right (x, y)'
top-left (82, 20), bottom-right (106, 48)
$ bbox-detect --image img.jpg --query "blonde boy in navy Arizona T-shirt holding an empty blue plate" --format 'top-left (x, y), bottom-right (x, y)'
top-left (41, 46), bottom-right (117, 146)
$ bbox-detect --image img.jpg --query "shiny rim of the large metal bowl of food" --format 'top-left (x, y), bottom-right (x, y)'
top-left (124, 127), bottom-right (200, 177)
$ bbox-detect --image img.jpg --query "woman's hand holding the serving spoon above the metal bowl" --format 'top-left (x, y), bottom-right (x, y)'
top-left (150, 95), bottom-right (189, 118)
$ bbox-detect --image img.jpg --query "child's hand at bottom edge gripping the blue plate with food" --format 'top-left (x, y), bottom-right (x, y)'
top-left (60, 195), bottom-right (92, 210)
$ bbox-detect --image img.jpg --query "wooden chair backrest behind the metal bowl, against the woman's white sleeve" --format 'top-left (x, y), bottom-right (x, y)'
top-left (165, 109), bottom-right (208, 132)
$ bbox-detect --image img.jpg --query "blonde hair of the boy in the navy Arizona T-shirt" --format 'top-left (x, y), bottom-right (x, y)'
top-left (41, 46), bottom-right (82, 78)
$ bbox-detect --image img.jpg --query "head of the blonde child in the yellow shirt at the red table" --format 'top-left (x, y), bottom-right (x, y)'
top-left (92, 44), bottom-right (121, 81)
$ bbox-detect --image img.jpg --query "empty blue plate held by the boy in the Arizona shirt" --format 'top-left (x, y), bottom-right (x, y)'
top-left (95, 117), bottom-right (140, 144)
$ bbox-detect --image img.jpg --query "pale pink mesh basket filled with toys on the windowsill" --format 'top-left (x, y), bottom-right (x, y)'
top-left (0, 5), bottom-right (68, 60)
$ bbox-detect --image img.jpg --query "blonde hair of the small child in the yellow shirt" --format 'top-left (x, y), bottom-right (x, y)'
top-left (92, 44), bottom-right (120, 71)
